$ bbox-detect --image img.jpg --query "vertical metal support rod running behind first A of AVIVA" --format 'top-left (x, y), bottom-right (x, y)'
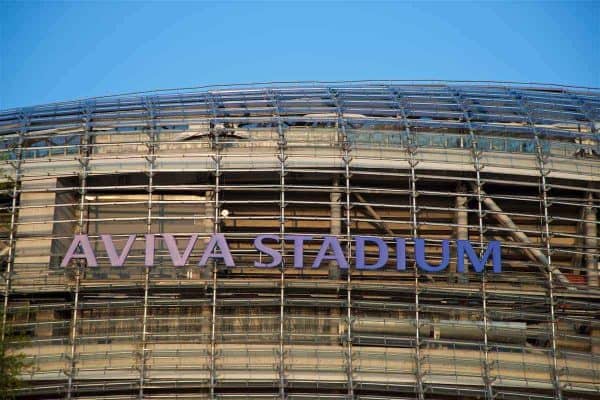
top-left (66, 104), bottom-right (93, 400)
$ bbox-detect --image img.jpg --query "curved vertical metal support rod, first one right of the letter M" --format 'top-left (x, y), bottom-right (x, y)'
top-left (511, 90), bottom-right (563, 400)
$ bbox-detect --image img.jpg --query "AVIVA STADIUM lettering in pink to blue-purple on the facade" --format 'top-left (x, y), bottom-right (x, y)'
top-left (61, 233), bottom-right (502, 273)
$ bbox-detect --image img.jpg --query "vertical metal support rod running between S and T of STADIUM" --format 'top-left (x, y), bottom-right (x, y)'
top-left (270, 92), bottom-right (287, 400)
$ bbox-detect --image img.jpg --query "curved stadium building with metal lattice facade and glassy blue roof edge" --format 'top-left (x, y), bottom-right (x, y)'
top-left (0, 81), bottom-right (600, 400)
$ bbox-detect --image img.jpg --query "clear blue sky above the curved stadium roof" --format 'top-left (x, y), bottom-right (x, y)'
top-left (0, 0), bottom-right (600, 109)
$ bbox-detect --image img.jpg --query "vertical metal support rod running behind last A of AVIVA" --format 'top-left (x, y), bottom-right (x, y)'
top-left (209, 92), bottom-right (221, 399)
